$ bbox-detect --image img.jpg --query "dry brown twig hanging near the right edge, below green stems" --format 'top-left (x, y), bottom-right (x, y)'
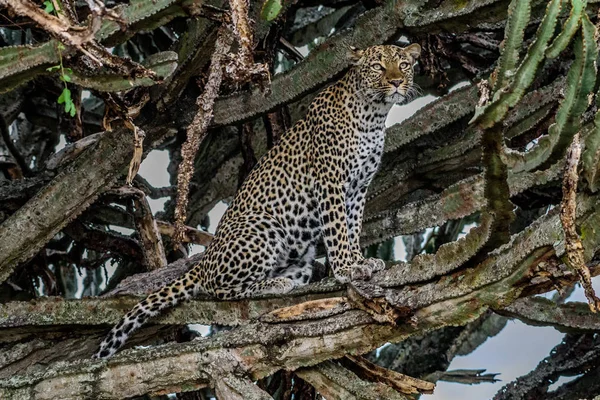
top-left (560, 133), bottom-right (600, 312)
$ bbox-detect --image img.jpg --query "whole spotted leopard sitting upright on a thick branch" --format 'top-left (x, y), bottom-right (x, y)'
top-left (93, 43), bottom-right (421, 358)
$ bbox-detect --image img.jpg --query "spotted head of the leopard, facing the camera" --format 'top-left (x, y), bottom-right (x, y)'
top-left (349, 43), bottom-right (421, 103)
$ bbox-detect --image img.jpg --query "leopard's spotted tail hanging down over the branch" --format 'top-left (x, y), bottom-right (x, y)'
top-left (93, 267), bottom-right (201, 358)
